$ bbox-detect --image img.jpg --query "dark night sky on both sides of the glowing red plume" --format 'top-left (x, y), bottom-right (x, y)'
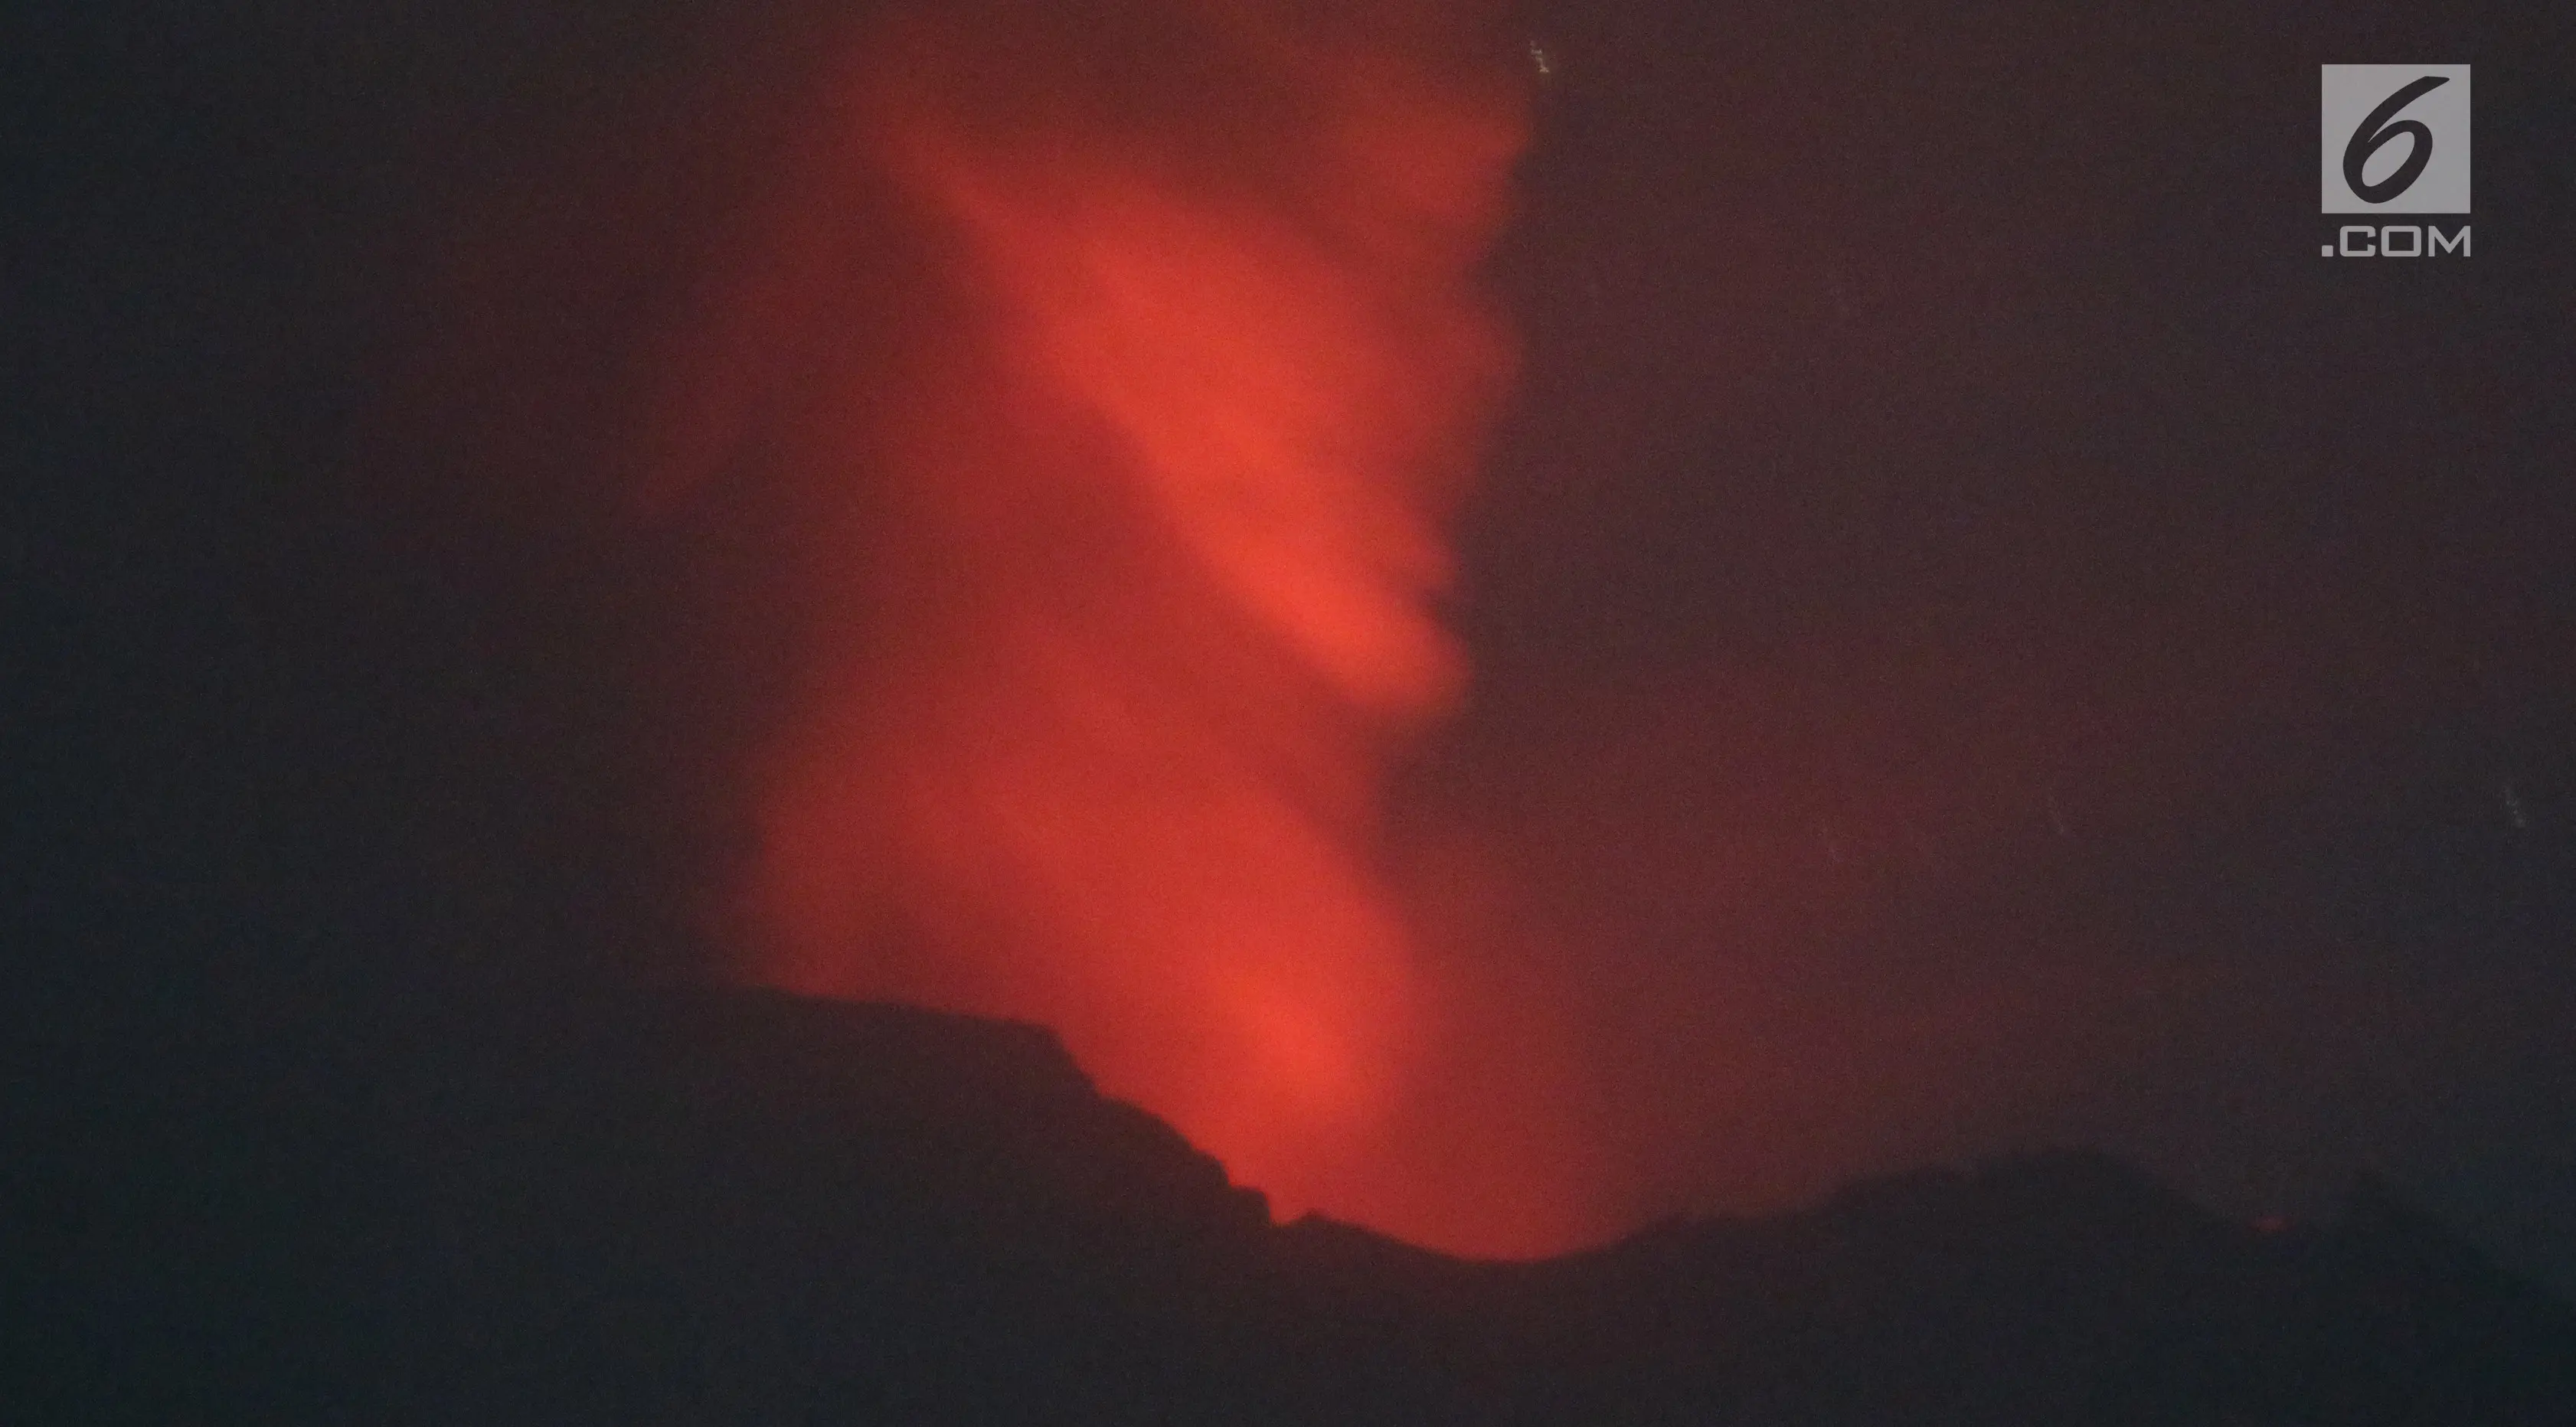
top-left (20, 0), bottom-right (2576, 1283)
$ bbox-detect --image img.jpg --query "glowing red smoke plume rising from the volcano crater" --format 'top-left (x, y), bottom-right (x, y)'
top-left (649, 0), bottom-right (1577, 1249)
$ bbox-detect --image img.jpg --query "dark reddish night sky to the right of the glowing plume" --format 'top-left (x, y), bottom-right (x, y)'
top-left (1417, 5), bottom-right (2576, 1272)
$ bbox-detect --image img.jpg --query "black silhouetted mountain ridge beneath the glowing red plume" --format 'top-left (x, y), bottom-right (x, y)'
top-left (25, 991), bottom-right (2576, 1427)
